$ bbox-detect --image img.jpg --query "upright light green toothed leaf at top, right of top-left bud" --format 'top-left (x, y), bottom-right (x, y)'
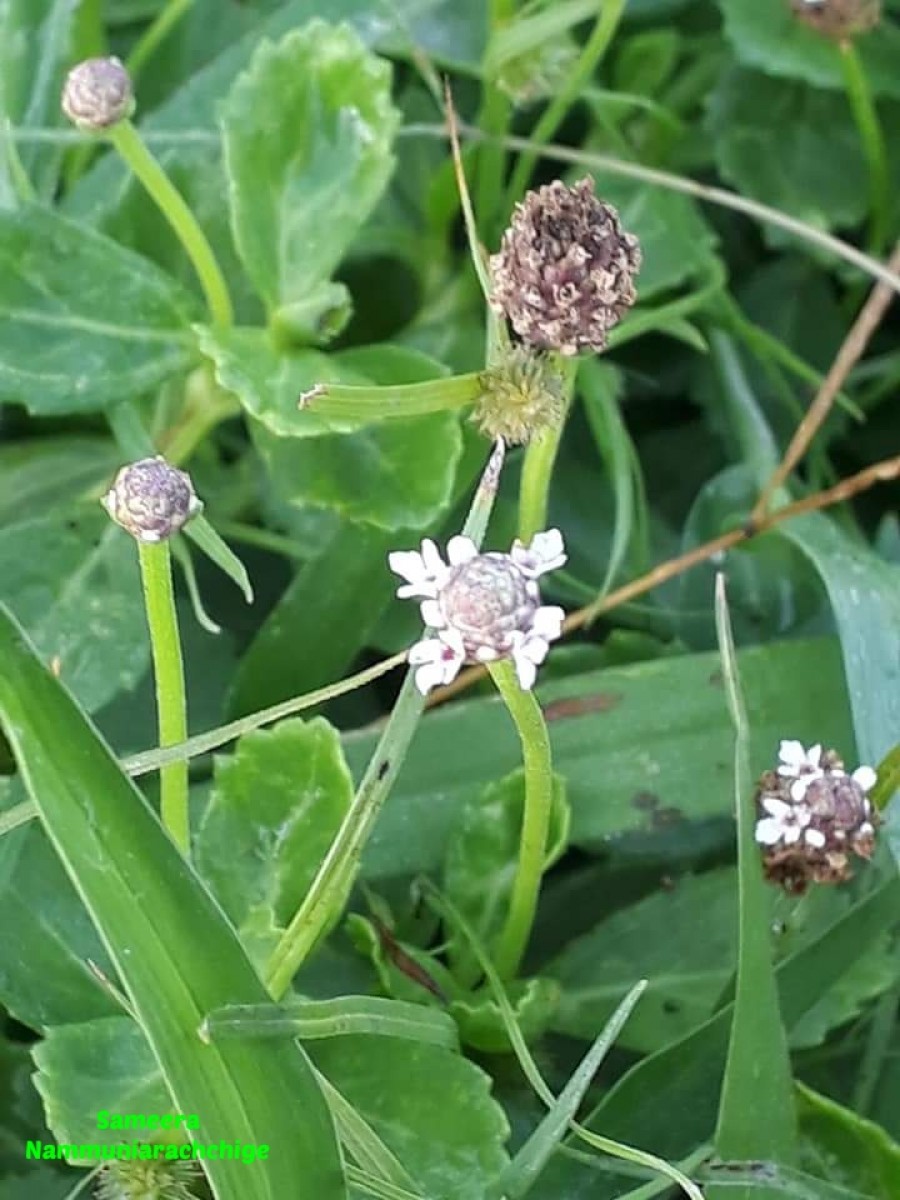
top-left (222, 20), bottom-right (400, 312)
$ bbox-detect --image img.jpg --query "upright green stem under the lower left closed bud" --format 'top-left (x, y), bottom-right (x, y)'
top-left (138, 541), bottom-right (191, 856)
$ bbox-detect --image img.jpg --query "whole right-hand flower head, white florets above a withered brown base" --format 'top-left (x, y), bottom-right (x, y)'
top-left (755, 740), bottom-right (878, 892)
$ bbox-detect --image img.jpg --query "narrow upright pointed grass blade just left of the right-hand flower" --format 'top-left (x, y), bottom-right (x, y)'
top-left (715, 575), bottom-right (797, 1180)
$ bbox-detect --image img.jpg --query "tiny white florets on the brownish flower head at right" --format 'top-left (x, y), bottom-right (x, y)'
top-left (756, 740), bottom-right (877, 850)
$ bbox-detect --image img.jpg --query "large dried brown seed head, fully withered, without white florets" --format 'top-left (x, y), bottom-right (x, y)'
top-left (491, 176), bottom-right (641, 354)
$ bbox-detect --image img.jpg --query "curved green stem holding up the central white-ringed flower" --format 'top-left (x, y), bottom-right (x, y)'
top-left (488, 661), bottom-right (553, 979)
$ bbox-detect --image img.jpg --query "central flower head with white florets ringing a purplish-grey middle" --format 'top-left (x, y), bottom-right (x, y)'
top-left (388, 529), bottom-right (565, 692)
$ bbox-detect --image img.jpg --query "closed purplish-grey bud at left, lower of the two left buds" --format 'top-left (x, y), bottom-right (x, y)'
top-left (102, 457), bottom-right (203, 541)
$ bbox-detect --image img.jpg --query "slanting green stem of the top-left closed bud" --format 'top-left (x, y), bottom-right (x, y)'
top-left (109, 121), bottom-right (234, 326)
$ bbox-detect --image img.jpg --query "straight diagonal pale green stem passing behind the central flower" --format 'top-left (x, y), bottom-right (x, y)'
top-left (264, 443), bottom-right (511, 1000)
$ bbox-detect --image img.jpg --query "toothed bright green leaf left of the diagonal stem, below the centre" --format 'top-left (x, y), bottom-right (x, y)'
top-left (194, 718), bottom-right (353, 964)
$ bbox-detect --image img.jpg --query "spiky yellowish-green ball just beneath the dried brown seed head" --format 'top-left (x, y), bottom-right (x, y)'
top-left (472, 346), bottom-right (565, 445)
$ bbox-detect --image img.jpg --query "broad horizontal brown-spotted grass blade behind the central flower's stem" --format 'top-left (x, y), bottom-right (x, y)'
top-left (344, 638), bottom-right (852, 878)
